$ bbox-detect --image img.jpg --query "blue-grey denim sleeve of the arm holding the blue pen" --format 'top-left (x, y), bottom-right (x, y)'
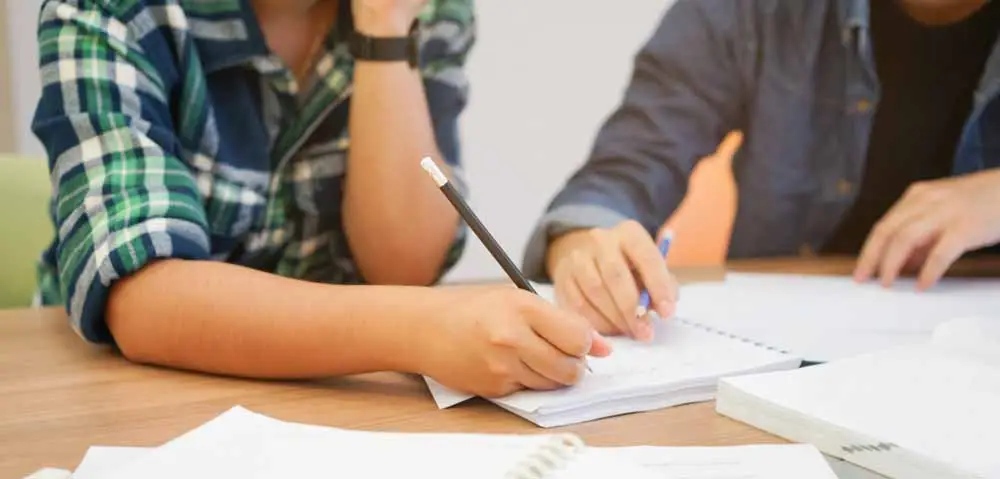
top-left (524, 0), bottom-right (743, 281)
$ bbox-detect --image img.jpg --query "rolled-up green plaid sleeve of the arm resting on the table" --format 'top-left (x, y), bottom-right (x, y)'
top-left (32, 0), bottom-right (209, 343)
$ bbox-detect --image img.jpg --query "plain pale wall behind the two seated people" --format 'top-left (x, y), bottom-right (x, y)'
top-left (3, 0), bottom-right (672, 280)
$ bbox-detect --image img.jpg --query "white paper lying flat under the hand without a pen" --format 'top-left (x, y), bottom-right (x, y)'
top-left (677, 273), bottom-right (1000, 361)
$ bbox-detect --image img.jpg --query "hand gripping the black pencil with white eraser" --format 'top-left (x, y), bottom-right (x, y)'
top-left (419, 287), bottom-right (611, 397)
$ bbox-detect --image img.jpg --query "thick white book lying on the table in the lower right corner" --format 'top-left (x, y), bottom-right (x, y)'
top-left (717, 318), bottom-right (1000, 479)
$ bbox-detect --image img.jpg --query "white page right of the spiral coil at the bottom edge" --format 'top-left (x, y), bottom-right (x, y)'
top-left (594, 444), bottom-right (837, 479)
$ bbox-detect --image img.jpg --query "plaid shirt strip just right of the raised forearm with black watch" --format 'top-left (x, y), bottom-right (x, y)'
top-left (421, 0), bottom-right (476, 274)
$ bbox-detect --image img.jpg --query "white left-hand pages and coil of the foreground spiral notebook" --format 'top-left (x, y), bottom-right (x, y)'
top-left (86, 407), bottom-right (655, 479)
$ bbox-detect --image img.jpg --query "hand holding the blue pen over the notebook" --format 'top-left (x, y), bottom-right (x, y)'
top-left (546, 221), bottom-right (678, 341)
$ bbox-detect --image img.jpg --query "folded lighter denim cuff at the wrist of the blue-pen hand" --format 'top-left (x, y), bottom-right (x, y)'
top-left (523, 204), bottom-right (630, 283)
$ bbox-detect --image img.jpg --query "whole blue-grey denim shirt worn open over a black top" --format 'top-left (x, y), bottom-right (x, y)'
top-left (524, 0), bottom-right (1000, 281)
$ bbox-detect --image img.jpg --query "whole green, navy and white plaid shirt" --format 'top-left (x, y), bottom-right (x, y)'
top-left (33, 0), bottom-right (475, 342)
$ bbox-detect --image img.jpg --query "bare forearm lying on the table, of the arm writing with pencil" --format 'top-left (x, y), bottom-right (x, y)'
top-left (107, 260), bottom-right (434, 378)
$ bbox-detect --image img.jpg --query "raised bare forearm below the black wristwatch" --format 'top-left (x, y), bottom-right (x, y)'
top-left (344, 62), bottom-right (458, 284)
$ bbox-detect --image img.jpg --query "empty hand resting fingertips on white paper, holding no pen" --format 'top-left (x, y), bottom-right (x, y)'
top-left (854, 171), bottom-right (1000, 289)
